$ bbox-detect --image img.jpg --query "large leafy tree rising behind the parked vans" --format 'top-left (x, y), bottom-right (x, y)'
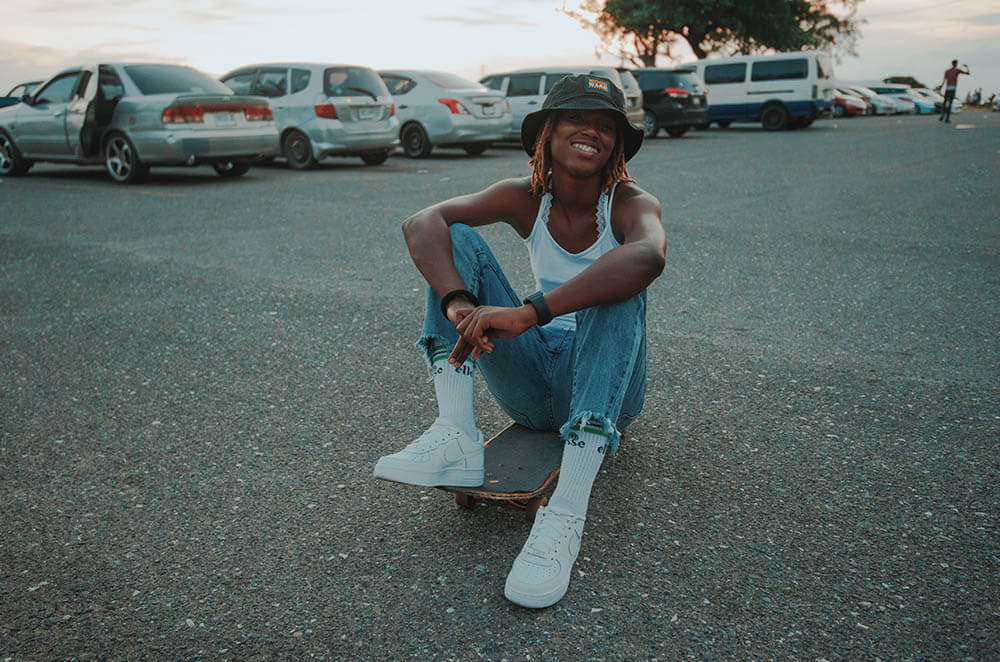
top-left (563, 0), bottom-right (863, 66)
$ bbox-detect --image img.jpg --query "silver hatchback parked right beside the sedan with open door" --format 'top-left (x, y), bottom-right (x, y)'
top-left (222, 62), bottom-right (399, 170)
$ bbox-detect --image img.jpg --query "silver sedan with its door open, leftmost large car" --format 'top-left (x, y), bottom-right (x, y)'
top-left (0, 63), bottom-right (278, 183)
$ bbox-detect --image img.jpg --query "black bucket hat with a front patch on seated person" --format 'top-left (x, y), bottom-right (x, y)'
top-left (521, 74), bottom-right (642, 161)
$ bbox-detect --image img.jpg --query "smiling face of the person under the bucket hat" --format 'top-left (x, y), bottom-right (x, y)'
top-left (550, 110), bottom-right (618, 176)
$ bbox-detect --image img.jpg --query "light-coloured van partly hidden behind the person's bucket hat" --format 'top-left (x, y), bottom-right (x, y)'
top-left (479, 67), bottom-right (643, 142)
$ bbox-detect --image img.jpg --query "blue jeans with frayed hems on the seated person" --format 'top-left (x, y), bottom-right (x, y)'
top-left (417, 224), bottom-right (646, 453)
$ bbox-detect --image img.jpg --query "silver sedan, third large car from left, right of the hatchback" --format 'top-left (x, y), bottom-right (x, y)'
top-left (379, 69), bottom-right (511, 159)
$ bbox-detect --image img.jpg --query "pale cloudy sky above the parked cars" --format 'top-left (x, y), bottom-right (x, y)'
top-left (0, 0), bottom-right (1000, 97)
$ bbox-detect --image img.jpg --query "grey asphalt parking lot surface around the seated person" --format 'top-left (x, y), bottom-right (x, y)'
top-left (0, 112), bottom-right (1000, 660)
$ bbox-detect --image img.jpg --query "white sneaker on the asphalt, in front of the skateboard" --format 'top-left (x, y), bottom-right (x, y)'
top-left (503, 506), bottom-right (584, 609)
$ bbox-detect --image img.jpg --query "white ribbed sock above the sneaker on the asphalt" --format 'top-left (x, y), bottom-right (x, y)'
top-left (549, 426), bottom-right (610, 517)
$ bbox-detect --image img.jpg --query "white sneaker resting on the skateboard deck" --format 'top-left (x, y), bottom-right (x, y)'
top-left (375, 419), bottom-right (484, 487)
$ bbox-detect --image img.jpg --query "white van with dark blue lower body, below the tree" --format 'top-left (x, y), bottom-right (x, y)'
top-left (692, 51), bottom-right (834, 131)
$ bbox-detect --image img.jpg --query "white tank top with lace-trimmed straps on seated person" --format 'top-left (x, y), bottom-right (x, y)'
top-left (524, 185), bottom-right (620, 329)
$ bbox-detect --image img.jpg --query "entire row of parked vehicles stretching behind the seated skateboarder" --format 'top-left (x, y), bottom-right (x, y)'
top-left (0, 52), bottom-right (961, 183)
